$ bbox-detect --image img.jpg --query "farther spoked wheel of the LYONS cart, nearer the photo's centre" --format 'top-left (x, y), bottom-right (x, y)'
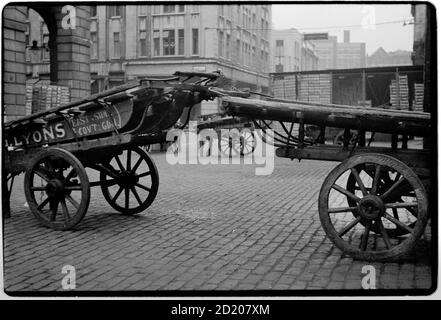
top-left (100, 147), bottom-right (159, 214)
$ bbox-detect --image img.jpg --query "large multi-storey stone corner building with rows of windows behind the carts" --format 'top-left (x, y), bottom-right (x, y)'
top-left (28, 4), bottom-right (271, 113)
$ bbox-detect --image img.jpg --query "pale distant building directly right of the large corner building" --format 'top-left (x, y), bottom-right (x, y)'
top-left (270, 29), bottom-right (318, 72)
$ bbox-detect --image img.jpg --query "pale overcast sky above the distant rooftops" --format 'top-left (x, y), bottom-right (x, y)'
top-left (272, 4), bottom-right (413, 54)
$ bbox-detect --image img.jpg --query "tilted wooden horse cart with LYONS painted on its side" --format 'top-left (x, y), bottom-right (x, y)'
top-left (2, 72), bottom-right (219, 230)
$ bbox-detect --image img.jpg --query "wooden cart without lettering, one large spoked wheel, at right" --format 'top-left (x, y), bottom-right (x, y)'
top-left (218, 96), bottom-right (432, 260)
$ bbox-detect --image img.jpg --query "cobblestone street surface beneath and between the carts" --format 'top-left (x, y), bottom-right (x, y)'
top-left (4, 153), bottom-right (431, 295)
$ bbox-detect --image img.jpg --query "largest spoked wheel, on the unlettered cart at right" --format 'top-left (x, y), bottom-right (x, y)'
top-left (319, 154), bottom-right (428, 261)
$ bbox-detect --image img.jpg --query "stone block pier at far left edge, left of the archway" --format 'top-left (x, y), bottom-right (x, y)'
top-left (2, 6), bottom-right (26, 121)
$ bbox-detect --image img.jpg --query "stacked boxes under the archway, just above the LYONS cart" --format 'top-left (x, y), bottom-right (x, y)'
top-left (26, 85), bottom-right (70, 114)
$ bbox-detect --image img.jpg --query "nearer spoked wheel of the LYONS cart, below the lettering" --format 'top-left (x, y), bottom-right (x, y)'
top-left (24, 148), bottom-right (90, 230)
